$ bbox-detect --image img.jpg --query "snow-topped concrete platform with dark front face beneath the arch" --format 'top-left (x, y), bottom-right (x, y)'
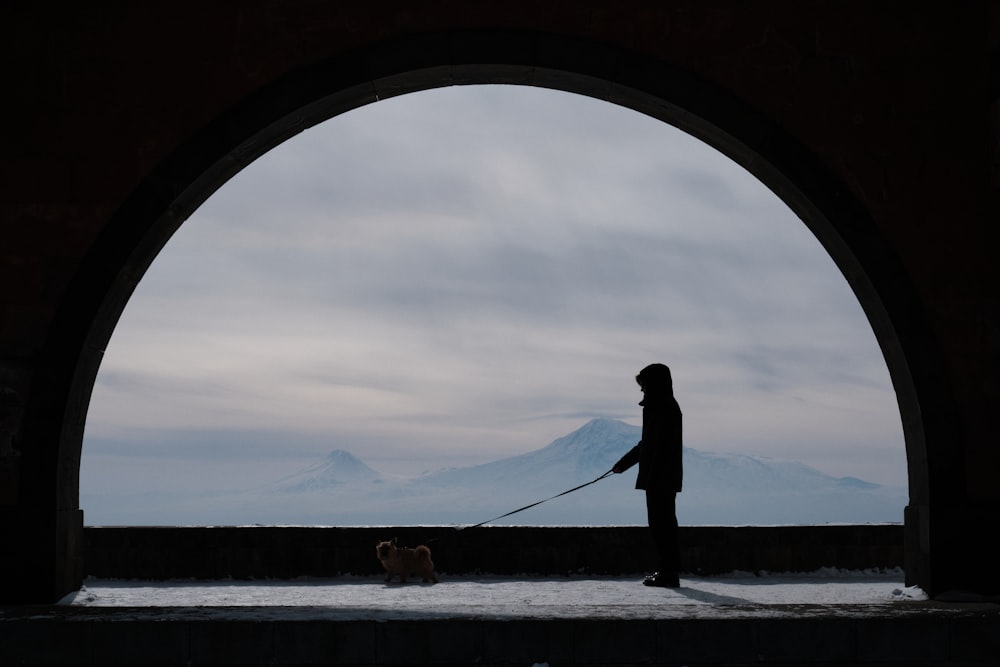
top-left (0, 573), bottom-right (1000, 667)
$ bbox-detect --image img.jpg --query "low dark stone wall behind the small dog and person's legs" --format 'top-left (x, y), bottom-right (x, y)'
top-left (84, 525), bottom-right (903, 580)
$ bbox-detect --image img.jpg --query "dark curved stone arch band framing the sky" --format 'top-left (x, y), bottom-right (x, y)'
top-left (11, 24), bottom-right (963, 590)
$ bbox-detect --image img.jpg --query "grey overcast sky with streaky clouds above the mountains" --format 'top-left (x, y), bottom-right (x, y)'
top-left (81, 86), bottom-right (906, 500)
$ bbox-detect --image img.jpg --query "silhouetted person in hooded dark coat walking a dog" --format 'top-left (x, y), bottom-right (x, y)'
top-left (612, 364), bottom-right (684, 588)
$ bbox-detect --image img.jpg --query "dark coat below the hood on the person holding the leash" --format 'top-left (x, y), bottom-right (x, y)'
top-left (615, 392), bottom-right (684, 493)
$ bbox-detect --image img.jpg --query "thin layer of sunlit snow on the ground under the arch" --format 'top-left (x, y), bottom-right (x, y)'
top-left (60, 570), bottom-right (927, 620)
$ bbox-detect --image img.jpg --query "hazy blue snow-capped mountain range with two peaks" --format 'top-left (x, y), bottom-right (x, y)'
top-left (80, 419), bottom-right (907, 526)
